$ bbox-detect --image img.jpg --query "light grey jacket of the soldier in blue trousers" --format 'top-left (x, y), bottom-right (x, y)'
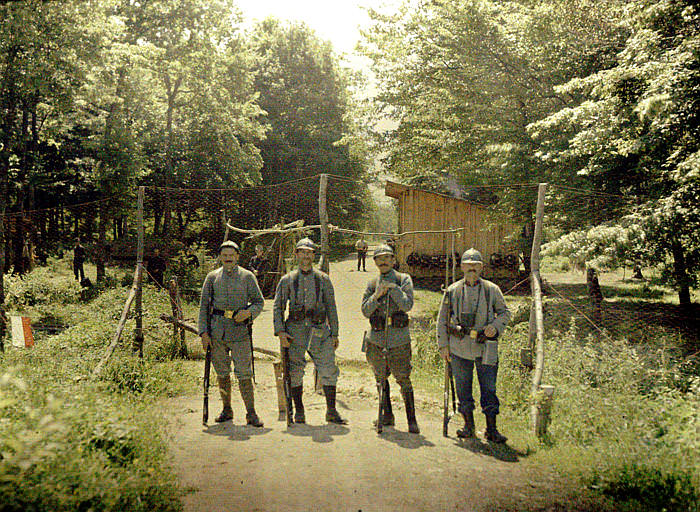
top-left (437, 278), bottom-right (510, 360)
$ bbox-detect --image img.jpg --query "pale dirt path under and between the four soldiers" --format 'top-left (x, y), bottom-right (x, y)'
top-left (163, 261), bottom-right (600, 512)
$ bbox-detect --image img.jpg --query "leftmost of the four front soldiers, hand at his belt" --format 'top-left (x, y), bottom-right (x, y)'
top-left (198, 241), bottom-right (264, 427)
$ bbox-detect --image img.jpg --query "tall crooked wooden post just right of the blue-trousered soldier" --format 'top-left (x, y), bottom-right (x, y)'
top-left (530, 183), bottom-right (554, 437)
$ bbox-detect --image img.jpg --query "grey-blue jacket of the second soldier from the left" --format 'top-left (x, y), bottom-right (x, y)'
top-left (273, 269), bottom-right (338, 338)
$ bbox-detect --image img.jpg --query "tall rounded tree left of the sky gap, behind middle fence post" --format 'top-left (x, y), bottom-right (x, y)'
top-left (251, 18), bottom-right (367, 228)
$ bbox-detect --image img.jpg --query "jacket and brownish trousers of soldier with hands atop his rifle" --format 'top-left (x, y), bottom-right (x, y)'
top-left (362, 269), bottom-right (413, 390)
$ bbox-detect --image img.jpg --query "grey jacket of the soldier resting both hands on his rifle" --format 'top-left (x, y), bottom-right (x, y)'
top-left (362, 269), bottom-right (413, 348)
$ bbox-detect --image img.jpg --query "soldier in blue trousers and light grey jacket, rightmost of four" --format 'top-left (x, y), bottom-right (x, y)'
top-left (437, 249), bottom-right (510, 443)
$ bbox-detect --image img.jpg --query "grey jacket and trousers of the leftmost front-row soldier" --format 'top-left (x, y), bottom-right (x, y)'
top-left (198, 266), bottom-right (264, 380)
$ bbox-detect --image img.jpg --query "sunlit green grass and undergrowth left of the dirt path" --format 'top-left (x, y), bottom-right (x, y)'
top-left (0, 259), bottom-right (198, 512)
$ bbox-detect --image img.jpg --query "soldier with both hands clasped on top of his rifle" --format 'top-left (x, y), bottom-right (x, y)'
top-left (362, 245), bottom-right (420, 434)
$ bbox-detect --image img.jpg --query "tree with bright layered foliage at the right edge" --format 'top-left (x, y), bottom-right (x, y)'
top-left (532, 0), bottom-right (700, 305)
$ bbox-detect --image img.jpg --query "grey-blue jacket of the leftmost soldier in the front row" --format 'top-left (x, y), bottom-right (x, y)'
top-left (198, 266), bottom-right (265, 341)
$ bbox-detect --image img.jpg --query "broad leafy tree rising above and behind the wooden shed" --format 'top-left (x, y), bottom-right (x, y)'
top-left (361, 0), bottom-right (622, 242)
